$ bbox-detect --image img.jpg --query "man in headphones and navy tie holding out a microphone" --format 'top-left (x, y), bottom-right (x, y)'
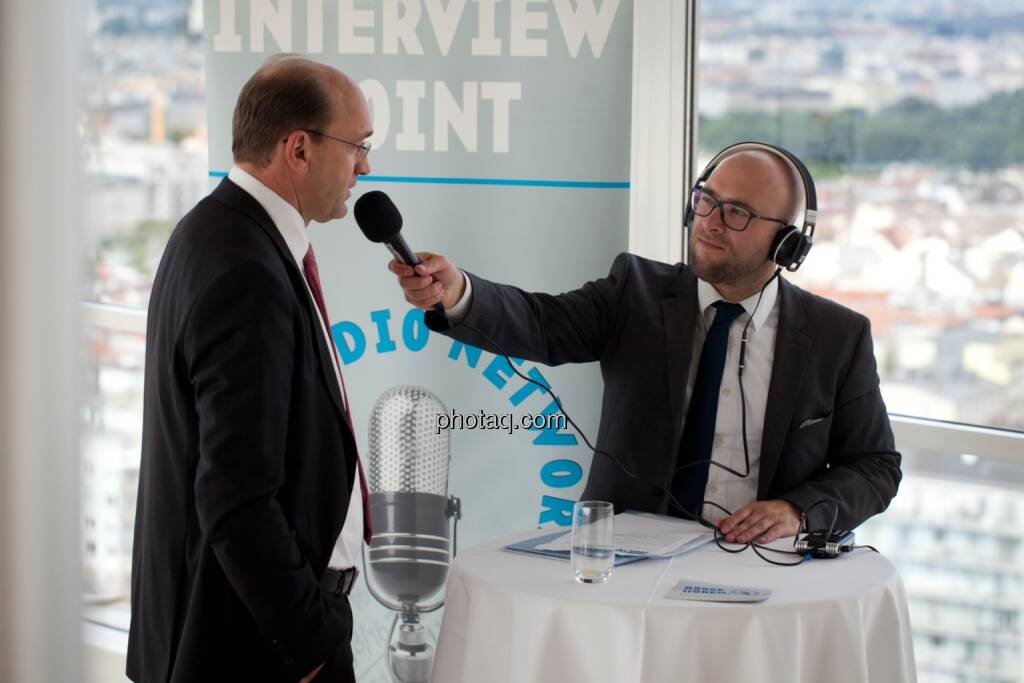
top-left (389, 145), bottom-right (900, 543)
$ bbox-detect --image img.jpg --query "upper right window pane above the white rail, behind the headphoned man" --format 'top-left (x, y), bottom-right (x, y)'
top-left (697, 0), bottom-right (1024, 430)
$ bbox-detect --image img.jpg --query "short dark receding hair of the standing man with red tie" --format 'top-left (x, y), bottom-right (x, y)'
top-left (231, 55), bottom-right (334, 168)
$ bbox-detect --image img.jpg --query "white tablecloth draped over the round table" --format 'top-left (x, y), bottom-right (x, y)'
top-left (432, 530), bottom-right (916, 683)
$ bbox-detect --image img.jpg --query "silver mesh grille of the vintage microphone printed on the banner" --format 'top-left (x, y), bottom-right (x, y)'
top-left (368, 385), bottom-right (451, 496)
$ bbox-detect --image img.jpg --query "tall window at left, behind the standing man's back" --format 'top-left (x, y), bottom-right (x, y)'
top-left (81, 0), bottom-right (209, 629)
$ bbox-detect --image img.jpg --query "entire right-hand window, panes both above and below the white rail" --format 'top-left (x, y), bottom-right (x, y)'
top-left (696, 0), bottom-right (1024, 683)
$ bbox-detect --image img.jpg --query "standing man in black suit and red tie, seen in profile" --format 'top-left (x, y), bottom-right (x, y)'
top-left (127, 55), bottom-right (372, 683)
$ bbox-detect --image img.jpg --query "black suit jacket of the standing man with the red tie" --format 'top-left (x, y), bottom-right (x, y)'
top-left (127, 178), bottom-right (355, 682)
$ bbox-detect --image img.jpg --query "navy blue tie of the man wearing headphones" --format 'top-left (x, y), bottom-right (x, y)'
top-left (669, 301), bottom-right (743, 517)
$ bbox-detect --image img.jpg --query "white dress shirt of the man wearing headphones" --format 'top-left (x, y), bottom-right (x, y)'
top-left (447, 268), bottom-right (778, 521)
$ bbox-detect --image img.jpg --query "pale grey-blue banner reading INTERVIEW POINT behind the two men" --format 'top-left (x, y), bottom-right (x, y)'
top-left (205, 0), bottom-right (633, 683)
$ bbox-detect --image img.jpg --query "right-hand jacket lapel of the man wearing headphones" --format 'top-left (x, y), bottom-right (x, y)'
top-left (758, 278), bottom-right (812, 500)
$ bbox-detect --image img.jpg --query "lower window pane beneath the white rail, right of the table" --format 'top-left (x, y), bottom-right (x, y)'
top-left (856, 449), bottom-right (1024, 683)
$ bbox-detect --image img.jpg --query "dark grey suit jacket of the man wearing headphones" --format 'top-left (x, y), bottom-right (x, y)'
top-left (450, 254), bottom-right (900, 528)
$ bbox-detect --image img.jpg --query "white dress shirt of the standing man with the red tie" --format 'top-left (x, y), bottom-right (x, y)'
top-left (227, 166), bottom-right (362, 569)
